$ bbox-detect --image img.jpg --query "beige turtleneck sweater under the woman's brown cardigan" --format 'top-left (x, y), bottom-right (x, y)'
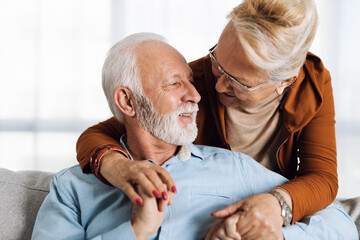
top-left (225, 92), bottom-right (283, 171)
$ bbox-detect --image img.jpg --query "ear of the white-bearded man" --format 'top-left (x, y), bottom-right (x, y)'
top-left (114, 87), bottom-right (136, 117)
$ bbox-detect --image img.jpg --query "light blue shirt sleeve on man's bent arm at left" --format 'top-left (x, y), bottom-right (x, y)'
top-left (32, 175), bottom-right (136, 240)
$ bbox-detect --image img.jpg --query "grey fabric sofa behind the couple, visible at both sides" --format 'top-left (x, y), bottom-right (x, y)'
top-left (0, 168), bottom-right (360, 240)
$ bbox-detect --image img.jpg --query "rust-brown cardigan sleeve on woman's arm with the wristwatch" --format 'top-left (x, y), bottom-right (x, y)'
top-left (281, 57), bottom-right (338, 223)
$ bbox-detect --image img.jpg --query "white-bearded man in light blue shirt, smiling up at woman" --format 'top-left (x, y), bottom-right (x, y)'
top-left (33, 33), bottom-right (357, 240)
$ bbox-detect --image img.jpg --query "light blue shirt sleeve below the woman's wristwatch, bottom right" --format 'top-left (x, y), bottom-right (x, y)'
top-left (282, 204), bottom-right (359, 240)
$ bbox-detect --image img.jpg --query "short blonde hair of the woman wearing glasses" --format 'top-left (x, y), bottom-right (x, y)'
top-left (229, 0), bottom-right (318, 81)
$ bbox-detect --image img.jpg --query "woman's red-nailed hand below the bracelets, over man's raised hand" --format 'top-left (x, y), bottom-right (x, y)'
top-left (100, 151), bottom-right (176, 209)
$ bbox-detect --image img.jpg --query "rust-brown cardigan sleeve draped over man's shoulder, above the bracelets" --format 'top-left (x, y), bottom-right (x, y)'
top-left (76, 117), bottom-right (126, 173)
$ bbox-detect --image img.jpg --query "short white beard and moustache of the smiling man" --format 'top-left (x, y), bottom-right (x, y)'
top-left (136, 96), bottom-right (199, 145)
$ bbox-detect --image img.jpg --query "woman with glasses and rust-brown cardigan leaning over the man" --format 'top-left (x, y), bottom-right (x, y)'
top-left (77, 0), bottom-right (338, 237)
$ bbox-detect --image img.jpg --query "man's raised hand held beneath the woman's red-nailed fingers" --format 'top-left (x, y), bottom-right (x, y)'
top-left (131, 186), bottom-right (168, 240)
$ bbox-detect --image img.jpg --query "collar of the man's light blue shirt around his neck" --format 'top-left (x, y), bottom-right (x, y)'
top-left (120, 133), bottom-right (204, 163)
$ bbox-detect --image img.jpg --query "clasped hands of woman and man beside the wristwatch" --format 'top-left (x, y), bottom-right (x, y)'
top-left (207, 193), bottom-right (283, 240)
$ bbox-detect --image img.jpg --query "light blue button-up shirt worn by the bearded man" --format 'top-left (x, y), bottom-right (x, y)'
top-left (32, 138), bottom-right (357, 240)
